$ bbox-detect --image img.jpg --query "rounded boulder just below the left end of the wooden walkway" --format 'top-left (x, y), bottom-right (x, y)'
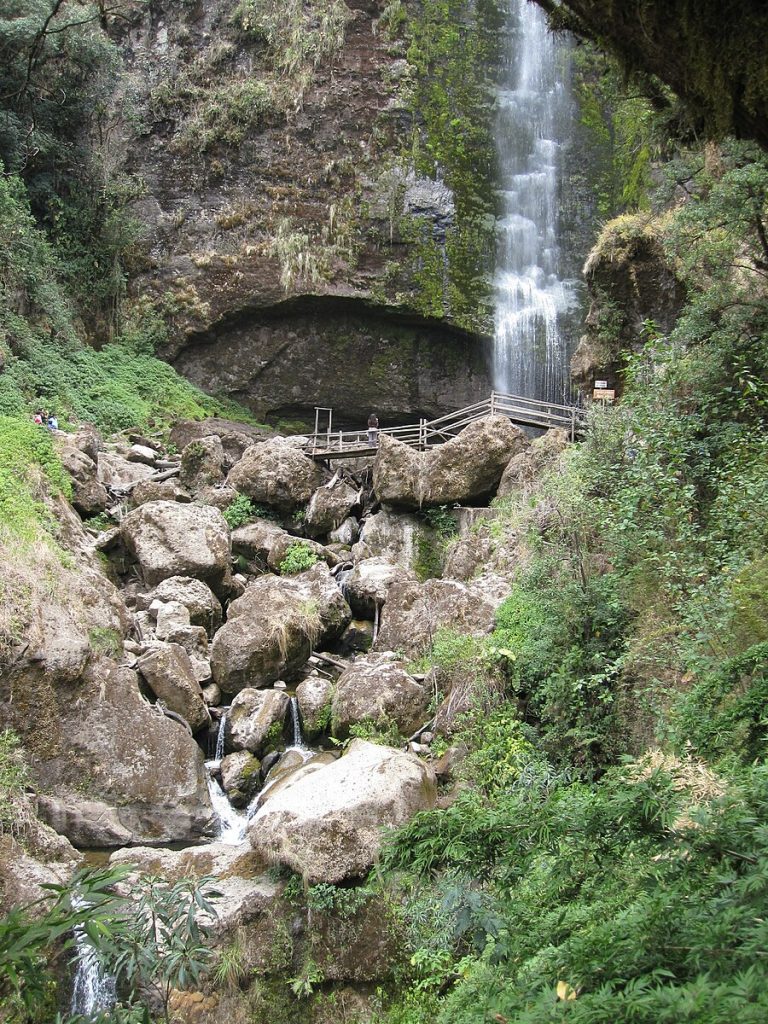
top-left (226, 438), bottom-right (324, 513)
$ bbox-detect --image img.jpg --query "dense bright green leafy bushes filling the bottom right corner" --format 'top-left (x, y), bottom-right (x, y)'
top-left (385, 762), bottom-right (768, 1024)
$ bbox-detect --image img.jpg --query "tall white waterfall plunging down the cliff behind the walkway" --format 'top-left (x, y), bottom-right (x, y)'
top-left (493, 0), bottom-right (575, 401)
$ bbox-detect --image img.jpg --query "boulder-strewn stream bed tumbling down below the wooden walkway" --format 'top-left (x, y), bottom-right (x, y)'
top-left (2, 417), bottom-right (566, 1021)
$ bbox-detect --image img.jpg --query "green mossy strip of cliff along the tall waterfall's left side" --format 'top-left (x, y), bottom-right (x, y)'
top-left (382, 0), bottom-right (502, 330)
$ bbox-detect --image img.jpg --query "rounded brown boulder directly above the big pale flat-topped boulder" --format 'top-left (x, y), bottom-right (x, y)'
top-left (331, 656), bottom-right (430, 739)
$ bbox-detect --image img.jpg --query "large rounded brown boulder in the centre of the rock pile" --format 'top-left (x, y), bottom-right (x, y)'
top-left (211, 565), bottom-right (350, 694)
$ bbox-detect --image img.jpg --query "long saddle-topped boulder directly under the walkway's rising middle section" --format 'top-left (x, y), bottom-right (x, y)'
top-left (374, 416), bottom-right (528, 509)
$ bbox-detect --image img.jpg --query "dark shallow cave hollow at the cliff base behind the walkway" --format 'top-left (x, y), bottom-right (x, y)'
top-left (173, 298), bottom-right (492, 429)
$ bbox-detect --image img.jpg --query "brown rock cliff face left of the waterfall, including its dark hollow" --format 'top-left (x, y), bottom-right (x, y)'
top-left (106, 0), bottom-right (501, 422)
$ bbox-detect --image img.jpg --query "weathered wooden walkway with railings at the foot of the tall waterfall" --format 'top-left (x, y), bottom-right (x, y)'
top-left (304, 391), bottom-right (587, 461)
